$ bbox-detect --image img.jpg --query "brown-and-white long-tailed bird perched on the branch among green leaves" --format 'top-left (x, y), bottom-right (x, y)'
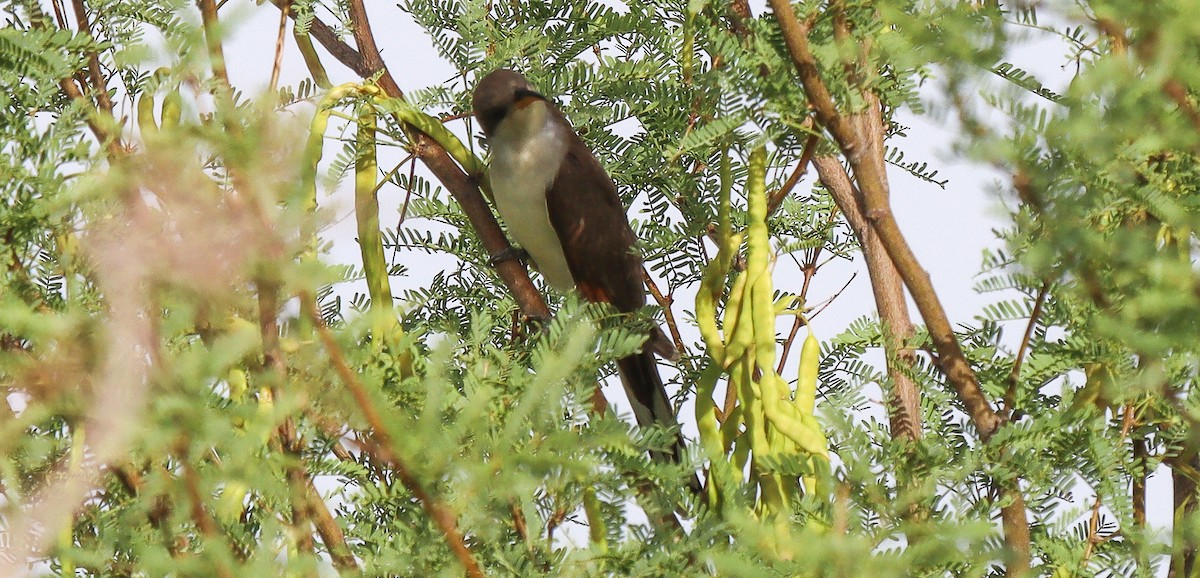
top-left (472, 68), bottom-right (695, 470)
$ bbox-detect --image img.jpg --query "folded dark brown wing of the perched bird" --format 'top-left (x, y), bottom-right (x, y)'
top-left (546, 119), bottom-right (646, 312)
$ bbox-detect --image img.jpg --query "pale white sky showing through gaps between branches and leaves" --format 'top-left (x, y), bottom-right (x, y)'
top-left (206, 0), bottom-right (1171, 568)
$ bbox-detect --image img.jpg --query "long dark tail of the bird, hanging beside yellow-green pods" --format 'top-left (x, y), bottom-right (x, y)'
top-left (617, 351), bottom-right (701, 492)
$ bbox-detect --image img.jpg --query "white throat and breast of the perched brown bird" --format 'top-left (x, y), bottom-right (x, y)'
top-left (490, 102), bottom-right (575, 293)
